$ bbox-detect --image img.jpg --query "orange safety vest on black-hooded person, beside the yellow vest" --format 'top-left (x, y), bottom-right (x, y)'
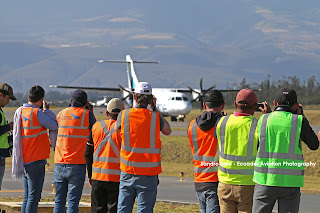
top-left (188, 120), bottom-right (219, 182)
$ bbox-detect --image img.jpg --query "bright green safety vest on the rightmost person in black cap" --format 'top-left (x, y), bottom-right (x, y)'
top-left (253, 111), bottom-right (305, 187)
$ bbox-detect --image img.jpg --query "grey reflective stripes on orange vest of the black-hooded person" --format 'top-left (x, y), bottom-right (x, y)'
top-left (191, 121), bottom-right (219, 173)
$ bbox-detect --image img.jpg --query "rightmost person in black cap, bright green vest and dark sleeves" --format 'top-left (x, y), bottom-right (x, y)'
top-left (253, 88), bottom-right (320, 213)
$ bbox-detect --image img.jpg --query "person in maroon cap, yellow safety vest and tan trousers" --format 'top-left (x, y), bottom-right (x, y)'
top-left (216, 89), bottom-right (268, 213)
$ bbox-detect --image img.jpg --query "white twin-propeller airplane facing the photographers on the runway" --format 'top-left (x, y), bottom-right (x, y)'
top-left (49, 55), bottom-right (239, 121)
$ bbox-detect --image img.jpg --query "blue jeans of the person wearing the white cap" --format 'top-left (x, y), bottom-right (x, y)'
top-left (118, 172), bottom-right (159, 213)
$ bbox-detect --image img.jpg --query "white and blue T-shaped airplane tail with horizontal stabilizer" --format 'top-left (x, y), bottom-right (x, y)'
top-left (98, 55), bottom-right (159, 91)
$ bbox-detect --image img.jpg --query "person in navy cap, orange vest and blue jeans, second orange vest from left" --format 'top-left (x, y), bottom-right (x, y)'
top-left (53, 89), bottom-right (96, 213)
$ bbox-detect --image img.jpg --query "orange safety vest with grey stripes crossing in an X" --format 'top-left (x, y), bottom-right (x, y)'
top-left (92, 119), bottom-right (121, 182)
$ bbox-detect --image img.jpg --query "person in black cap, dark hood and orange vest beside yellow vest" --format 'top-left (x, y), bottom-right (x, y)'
top-left (188, 90), bottom-right (225, 213)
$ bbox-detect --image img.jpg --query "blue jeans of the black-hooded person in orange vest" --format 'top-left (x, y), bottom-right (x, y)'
top-left (196, 187), bottom-right (220, 213)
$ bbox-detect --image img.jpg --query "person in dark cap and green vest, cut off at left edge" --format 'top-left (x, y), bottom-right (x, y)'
top-left (0, 83), bottom-right (17, 190)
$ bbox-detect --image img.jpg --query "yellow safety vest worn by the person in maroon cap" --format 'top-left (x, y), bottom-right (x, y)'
top-left (216, 115), bottom-right (258, 185)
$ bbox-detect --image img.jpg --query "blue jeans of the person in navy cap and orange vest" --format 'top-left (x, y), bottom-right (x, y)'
top-left (53, 164), bottom-right (86, 213)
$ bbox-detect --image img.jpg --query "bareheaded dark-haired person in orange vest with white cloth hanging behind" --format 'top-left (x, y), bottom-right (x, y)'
top-left (12, 85), bottom-right (58, 213)
